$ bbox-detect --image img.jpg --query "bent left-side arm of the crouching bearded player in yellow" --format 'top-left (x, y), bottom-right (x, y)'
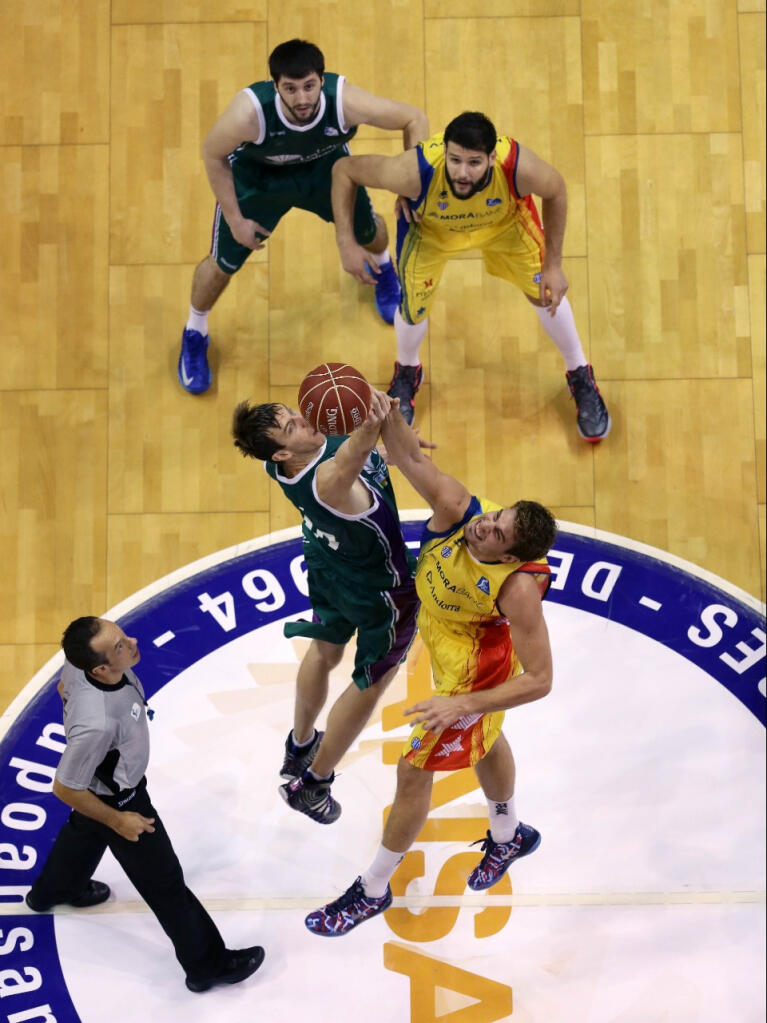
top-left (330, 149), bottom-right (420, 284)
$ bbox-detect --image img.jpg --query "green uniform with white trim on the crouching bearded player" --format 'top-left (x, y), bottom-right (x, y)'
top-left (211, 72), bottom-right (375, 273)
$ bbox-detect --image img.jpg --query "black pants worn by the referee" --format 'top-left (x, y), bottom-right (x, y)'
top-left (30, 779), bottom-right (225, 980)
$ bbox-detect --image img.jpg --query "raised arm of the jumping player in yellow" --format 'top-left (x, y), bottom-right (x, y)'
top-left (381, 399), bottom-right (471, 533)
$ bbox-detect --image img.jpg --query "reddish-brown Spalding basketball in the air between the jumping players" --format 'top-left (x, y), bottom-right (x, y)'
top-left (299, 362), bottom-right (370, 437)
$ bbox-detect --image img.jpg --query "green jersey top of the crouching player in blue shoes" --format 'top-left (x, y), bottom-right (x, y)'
top-left (229, 72), bottom-right (357, 167)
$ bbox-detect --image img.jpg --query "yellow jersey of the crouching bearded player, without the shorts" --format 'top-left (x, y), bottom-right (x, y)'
top-left (411, 132), bottom-right (525, 252)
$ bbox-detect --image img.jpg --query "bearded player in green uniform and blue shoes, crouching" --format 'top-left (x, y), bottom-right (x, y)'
top-left (178, 39), bottom-right (428, 394)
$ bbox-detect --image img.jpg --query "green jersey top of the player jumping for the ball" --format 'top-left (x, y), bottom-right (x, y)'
top-left (264, 437), bottom-right (415, 590)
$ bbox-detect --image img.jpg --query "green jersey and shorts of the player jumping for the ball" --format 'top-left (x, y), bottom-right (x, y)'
top-left (265, 437), bottom-right (418, 688)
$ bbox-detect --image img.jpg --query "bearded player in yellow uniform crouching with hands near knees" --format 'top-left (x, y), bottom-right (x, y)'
top-left (332, 112), bottom-right (611, 442)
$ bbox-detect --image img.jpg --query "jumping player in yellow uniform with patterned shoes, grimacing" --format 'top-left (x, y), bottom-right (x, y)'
top-left (306, 403), bottom-right (556, 937)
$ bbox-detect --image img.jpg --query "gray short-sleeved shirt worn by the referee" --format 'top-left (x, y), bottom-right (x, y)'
top-left (56, 661), bottom-right (149, 796)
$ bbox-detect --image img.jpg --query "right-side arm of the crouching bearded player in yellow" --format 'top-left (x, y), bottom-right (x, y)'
top-left (516, 146), bottom-right (569, 315)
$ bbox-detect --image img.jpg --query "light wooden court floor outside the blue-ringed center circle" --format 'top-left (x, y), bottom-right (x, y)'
top-left (0, 0), bottom-right (765, 706)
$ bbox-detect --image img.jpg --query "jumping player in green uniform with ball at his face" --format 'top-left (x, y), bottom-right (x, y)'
top-left (232, 391), bottom-right (418, 824)
